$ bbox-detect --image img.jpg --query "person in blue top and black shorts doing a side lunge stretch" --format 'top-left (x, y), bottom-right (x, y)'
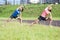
top-left (7, 6), bottom-right (23, 23)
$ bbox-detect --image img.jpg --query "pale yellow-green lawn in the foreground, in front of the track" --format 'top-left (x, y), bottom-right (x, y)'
top-left (0, 21), bottom-right (60, 40)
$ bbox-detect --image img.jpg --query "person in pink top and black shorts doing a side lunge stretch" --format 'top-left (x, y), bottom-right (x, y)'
top-left (31, 5), bottom-right (52, 25)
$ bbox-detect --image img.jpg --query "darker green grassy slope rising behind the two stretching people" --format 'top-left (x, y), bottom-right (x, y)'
top-left (0, 4), bottom-right (60, 18)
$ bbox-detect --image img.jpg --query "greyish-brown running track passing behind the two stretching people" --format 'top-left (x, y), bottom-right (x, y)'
top-left (0, 20), bottom-right (60, 27)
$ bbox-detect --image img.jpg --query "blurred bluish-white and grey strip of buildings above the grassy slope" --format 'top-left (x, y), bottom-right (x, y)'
top-left (0, 0), bottom-right (60, 5)
